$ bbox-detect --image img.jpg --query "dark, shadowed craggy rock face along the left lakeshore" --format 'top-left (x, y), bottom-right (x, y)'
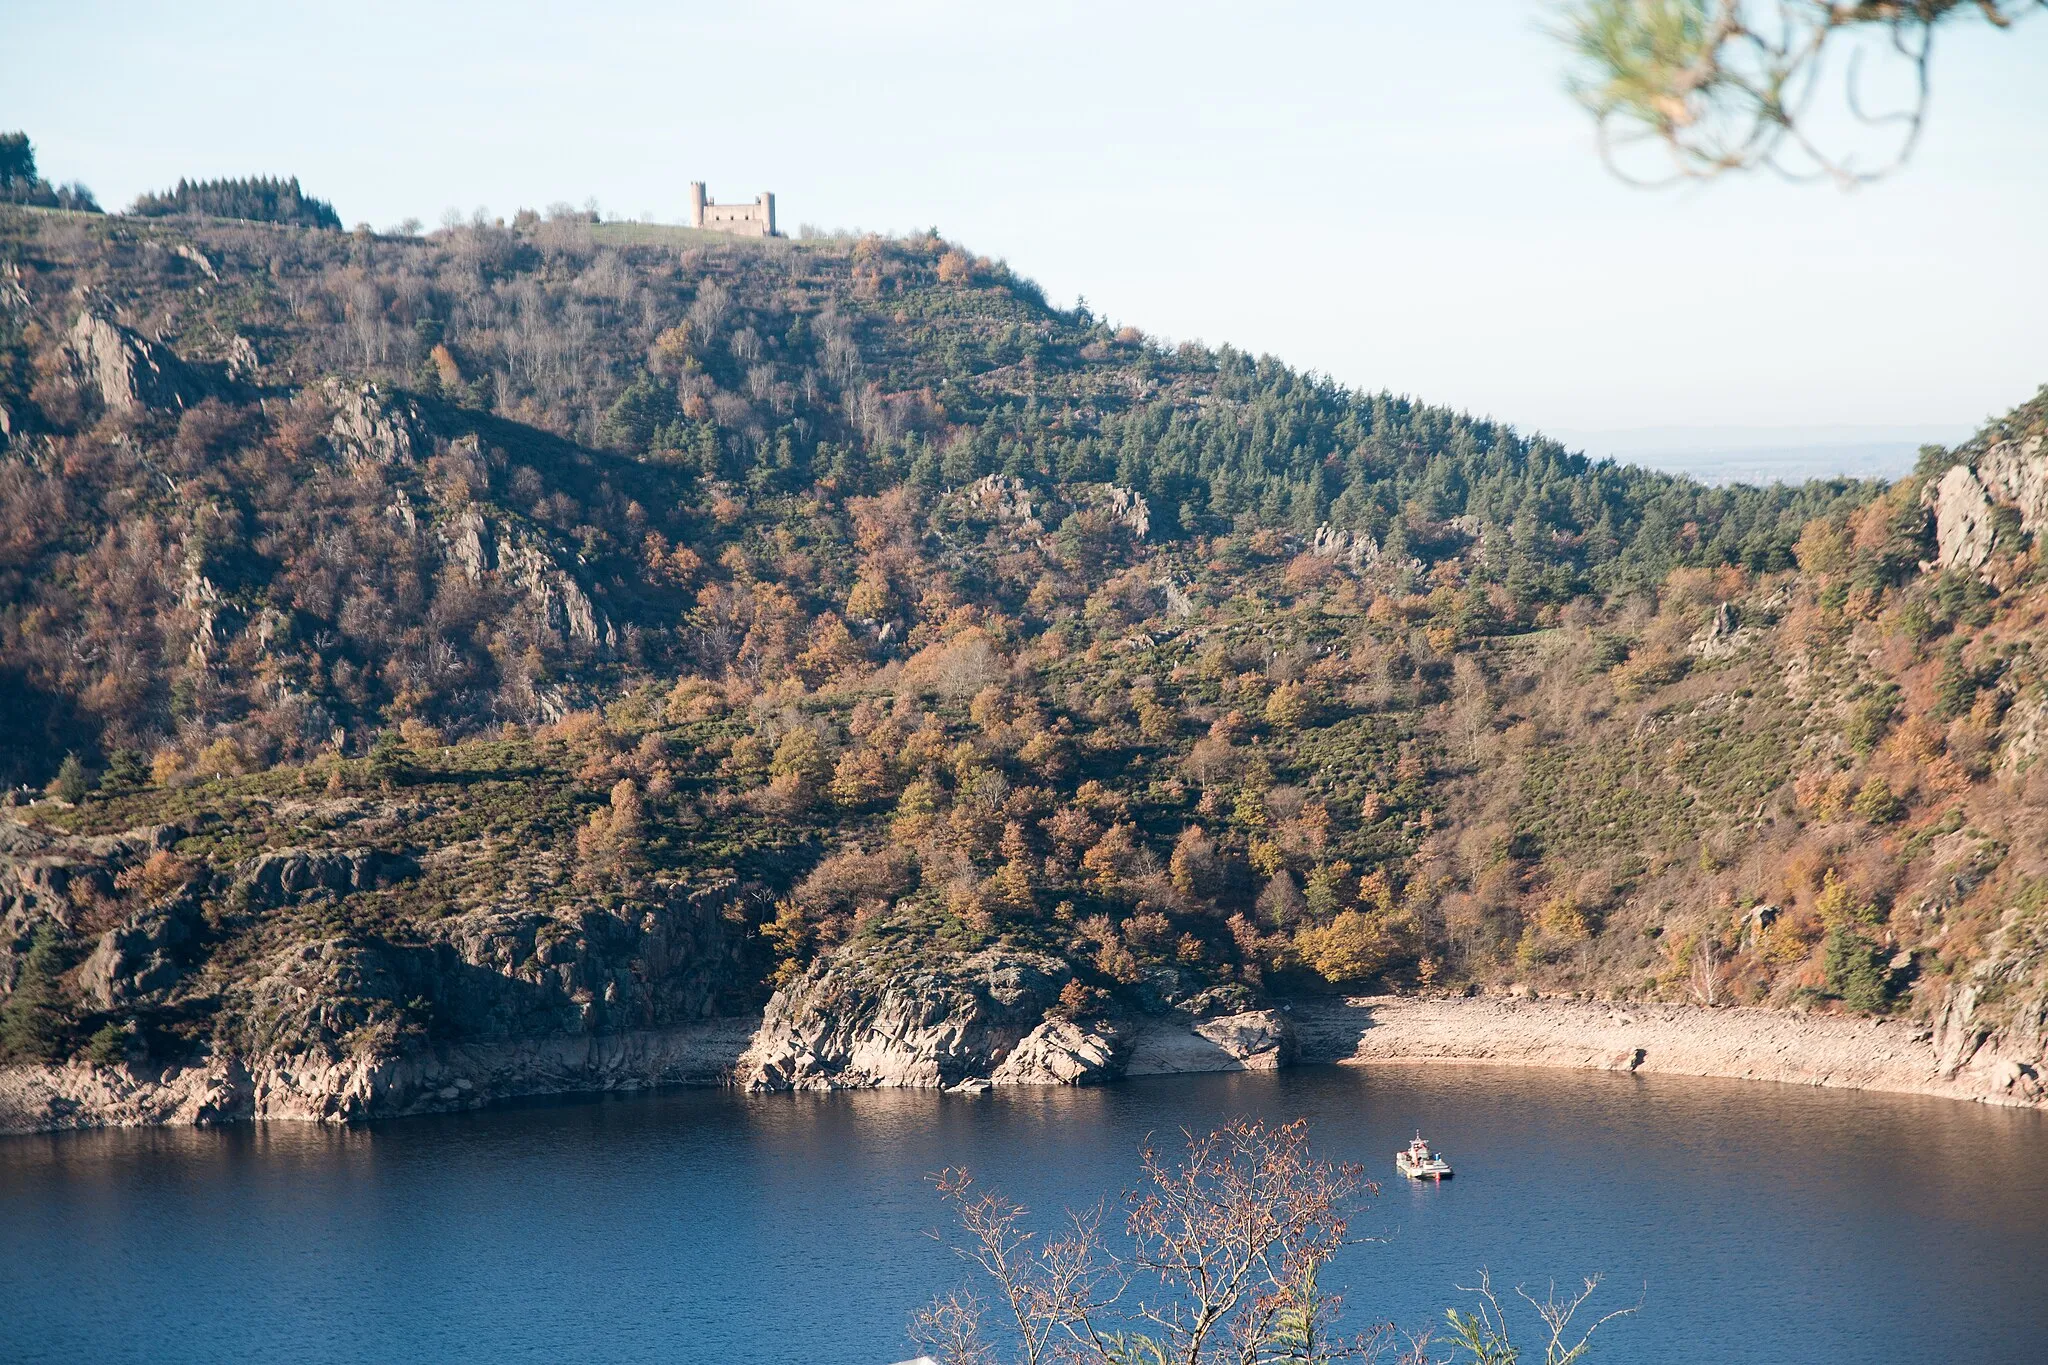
top-left (0, 818), bottom-right (758, 1132)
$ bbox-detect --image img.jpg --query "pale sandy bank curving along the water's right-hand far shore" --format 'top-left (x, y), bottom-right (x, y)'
top-left (1290, 995), bottom-right (2044, 1107)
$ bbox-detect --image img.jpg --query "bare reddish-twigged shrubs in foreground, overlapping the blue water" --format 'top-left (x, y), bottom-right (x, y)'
top-left (911, 1119), bottom-right (1632, 1365)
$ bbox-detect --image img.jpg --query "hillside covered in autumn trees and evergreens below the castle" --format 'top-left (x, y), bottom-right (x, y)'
top-left (0, 209), bottom-right (2048, 1096)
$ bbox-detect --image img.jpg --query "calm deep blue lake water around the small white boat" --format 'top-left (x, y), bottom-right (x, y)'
top-left (0, 1066), bottom-right (2048, 1365)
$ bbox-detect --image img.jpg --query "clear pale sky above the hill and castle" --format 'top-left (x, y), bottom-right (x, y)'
top-left (16, 0), bottom-right (2048, 444)
